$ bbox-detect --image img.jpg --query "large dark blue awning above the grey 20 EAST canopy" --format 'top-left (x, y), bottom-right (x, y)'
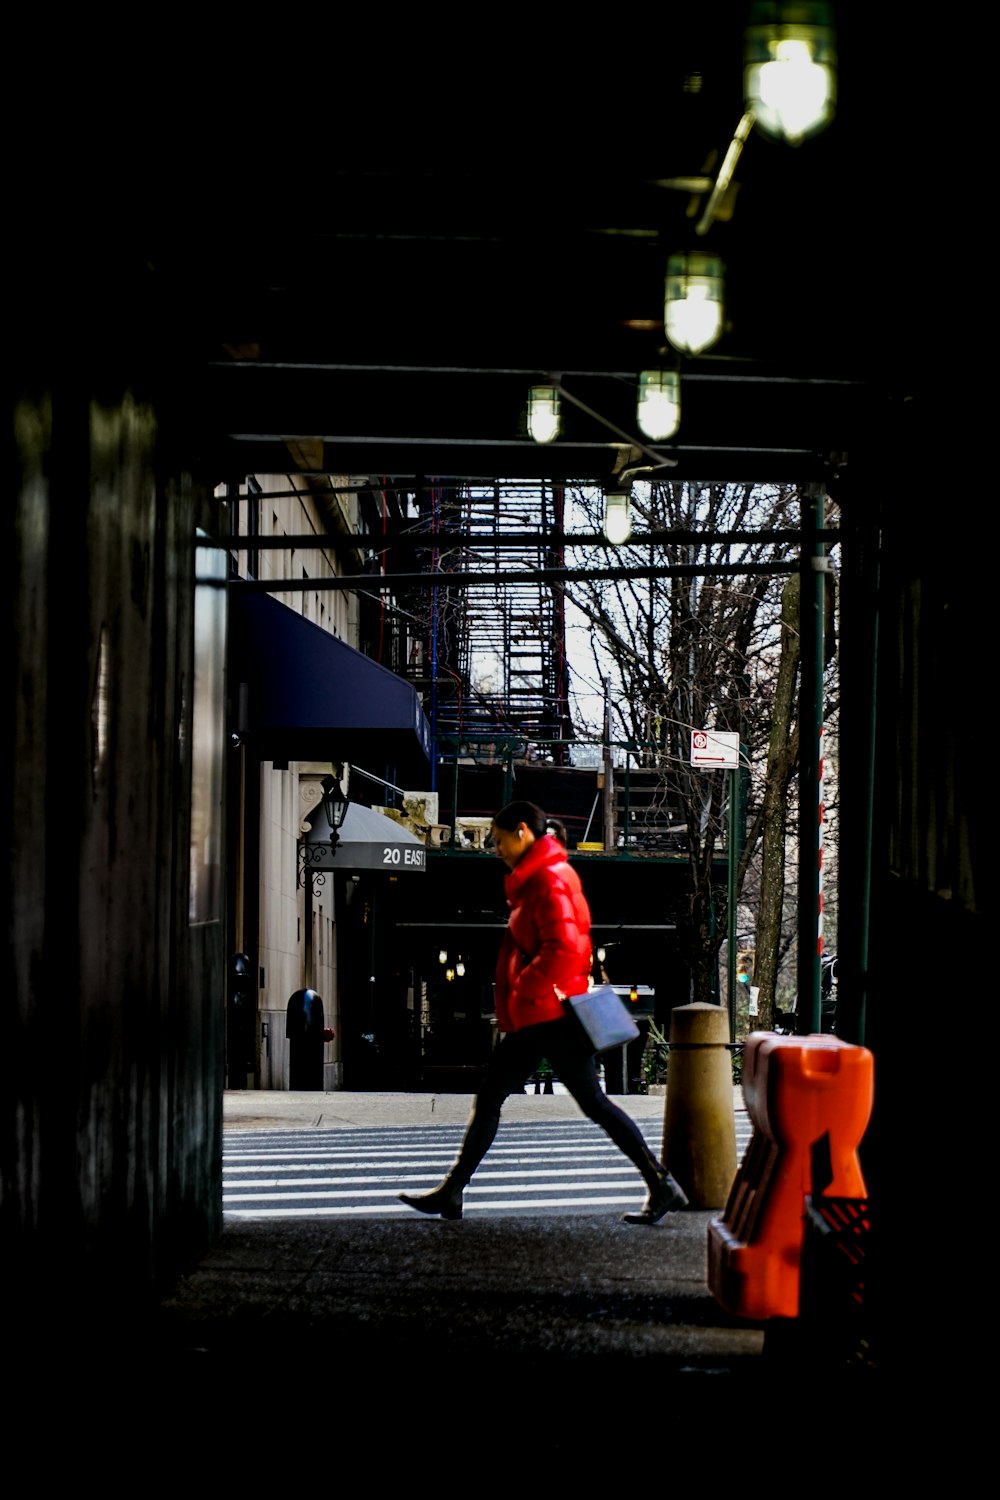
top-left (229, 585), bottom-right (430, 788)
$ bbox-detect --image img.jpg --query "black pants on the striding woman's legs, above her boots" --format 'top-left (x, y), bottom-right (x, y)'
top-left (448, 1016), bottom-right (663, 1188)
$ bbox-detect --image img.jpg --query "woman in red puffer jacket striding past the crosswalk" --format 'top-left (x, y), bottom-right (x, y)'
top-left (399, 803), bottom-right (688, 1224)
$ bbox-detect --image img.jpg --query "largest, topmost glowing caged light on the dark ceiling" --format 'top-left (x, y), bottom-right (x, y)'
top-left (744, 0), bottom-right (837, 146)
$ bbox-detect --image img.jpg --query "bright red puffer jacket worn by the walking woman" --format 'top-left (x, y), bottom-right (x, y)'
top-left (496, 834), bottom-right (591, 1032)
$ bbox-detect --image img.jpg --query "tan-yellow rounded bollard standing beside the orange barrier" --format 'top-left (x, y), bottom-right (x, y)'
top-left (663, 1005), bottom-right (736, 1209)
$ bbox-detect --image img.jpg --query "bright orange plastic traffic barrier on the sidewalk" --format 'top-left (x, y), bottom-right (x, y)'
top-left (708, 1032), bottom-right (874, 1319)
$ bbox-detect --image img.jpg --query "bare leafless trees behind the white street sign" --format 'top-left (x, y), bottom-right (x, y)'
top-left (567, 483), bottom-right (839, 1028)
